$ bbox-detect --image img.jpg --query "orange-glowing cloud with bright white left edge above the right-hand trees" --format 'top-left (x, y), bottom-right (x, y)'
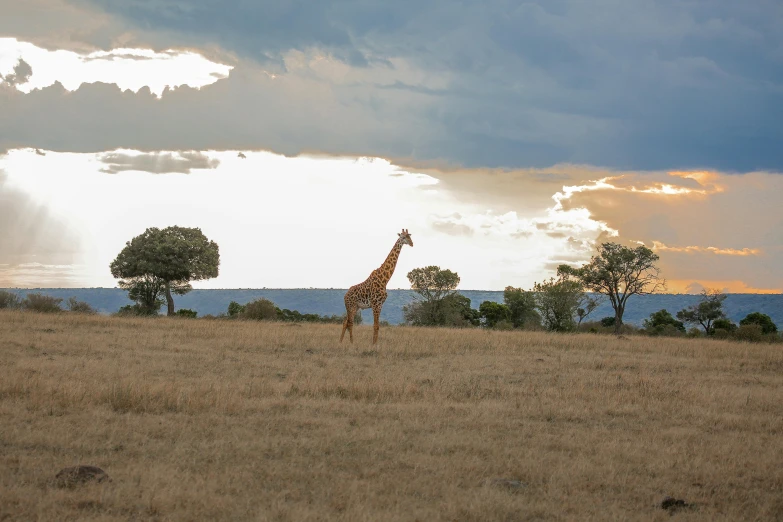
top-left (555, 167), bottom-right (783, 291)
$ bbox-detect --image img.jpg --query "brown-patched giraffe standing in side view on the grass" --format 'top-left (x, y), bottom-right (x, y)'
top-left (340, 229), bottom-right (413, 344)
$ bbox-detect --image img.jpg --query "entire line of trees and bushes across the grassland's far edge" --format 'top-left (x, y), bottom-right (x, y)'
top-left (0, 226), bottom-right (780, 341)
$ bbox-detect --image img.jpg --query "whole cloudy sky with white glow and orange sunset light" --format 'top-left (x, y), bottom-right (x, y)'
top-left (0, 0), bottom-right (783, 293)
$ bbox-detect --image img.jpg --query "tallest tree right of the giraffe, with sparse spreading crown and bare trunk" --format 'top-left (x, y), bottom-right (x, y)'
top-left (558, 243), bottom-right (666, 333)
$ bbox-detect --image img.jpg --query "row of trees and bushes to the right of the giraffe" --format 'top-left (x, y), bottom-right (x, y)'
top-left (403, 243), bottom-right (780, 342)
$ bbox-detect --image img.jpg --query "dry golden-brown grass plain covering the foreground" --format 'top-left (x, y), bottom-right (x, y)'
top-left (0, 312), bottom-right (783, 520)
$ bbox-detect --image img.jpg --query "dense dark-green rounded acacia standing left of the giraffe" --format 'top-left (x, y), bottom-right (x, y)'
top-left (109, 226), bottom-right (220, 315)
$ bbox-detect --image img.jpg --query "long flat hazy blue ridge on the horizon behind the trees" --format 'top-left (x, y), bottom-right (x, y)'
top-left (6, 288), bottom-right (783, 328)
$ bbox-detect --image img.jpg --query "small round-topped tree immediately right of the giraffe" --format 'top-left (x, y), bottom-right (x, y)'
top-left (403, 265), bottom-right (459, 326)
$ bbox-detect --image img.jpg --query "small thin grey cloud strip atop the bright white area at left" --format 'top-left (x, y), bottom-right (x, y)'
top-left (99, 151), bottom-right (220, 174)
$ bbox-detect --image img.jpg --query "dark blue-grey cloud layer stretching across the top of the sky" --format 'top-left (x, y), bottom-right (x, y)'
top-left (0, 0), bottom-right (783, 170)
